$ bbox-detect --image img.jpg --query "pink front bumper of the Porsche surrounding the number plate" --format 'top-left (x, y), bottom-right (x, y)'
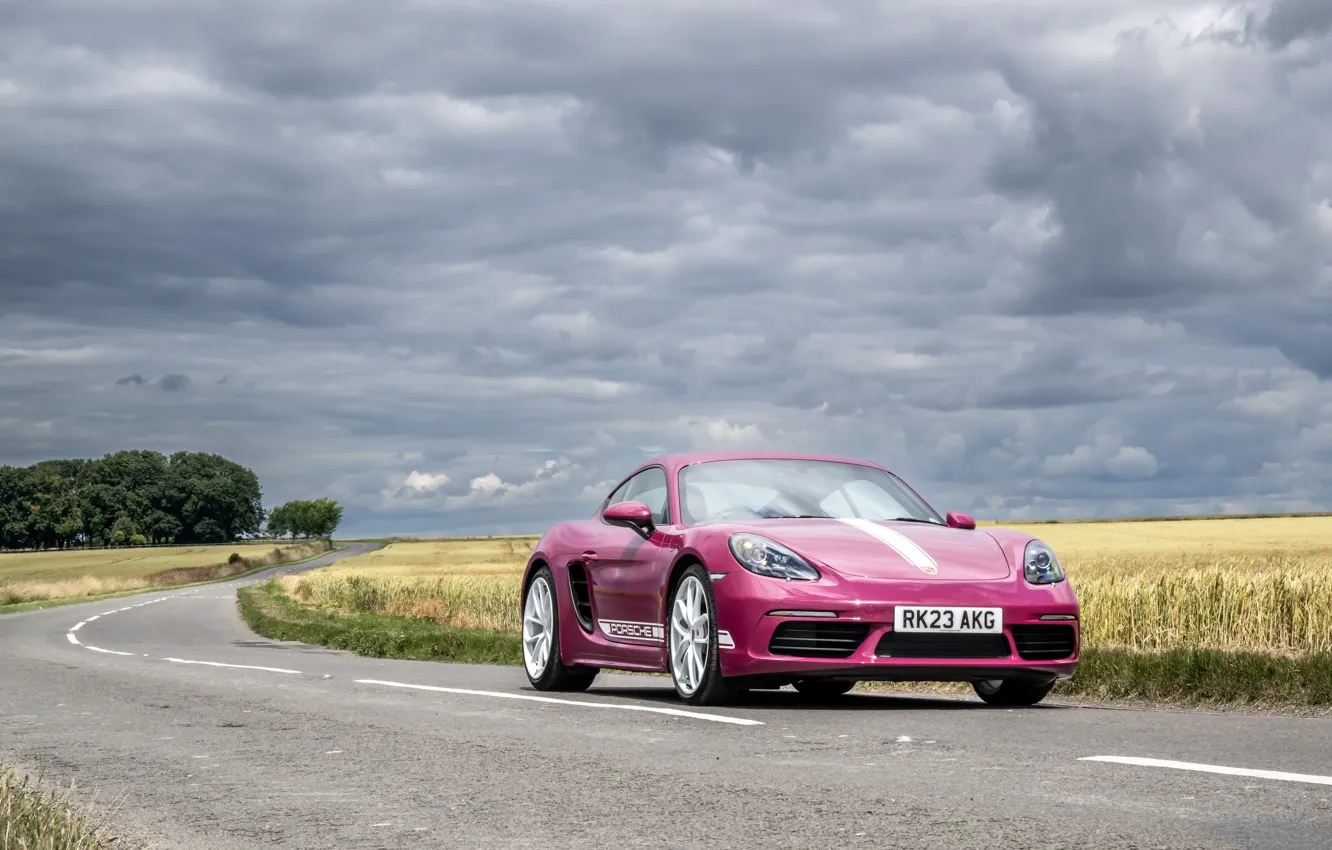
top-left (713, 568), bottom-right (1082, 682)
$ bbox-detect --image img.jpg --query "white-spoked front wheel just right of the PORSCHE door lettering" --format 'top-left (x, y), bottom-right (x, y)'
top-left (666, 564), bottom-right (747, 705)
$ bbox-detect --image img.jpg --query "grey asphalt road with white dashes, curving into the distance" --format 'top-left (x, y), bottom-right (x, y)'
top-left (0, 545), bottom-right (1332, 850)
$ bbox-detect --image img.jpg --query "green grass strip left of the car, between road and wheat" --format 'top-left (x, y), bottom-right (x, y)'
top-left (238, 581), bottom-right (522, 665)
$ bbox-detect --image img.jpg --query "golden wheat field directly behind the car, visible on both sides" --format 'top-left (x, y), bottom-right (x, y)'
top-left (284, 517), bottom-right (1332, 653)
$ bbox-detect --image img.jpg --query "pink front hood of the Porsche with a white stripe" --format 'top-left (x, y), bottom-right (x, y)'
top-left (735, 518), bottom-right (1011, 581)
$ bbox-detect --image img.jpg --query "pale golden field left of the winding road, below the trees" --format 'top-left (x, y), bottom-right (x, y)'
top-left (0, 544), bottom-right (322, 605)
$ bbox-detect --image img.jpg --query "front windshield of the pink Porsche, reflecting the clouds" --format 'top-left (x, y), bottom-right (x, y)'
top-left (679, 460), bottom-right (943, 524)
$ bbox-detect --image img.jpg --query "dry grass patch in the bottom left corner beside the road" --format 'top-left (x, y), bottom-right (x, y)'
top-left (0, 767), bottom-right (132, 850)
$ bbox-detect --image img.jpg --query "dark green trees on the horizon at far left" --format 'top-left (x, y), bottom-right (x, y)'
top-left (0, 450), bottom-right (342, 549)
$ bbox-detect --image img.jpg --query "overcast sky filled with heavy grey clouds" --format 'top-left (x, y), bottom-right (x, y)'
top-left (0, 0), bottom-right (1332, 534)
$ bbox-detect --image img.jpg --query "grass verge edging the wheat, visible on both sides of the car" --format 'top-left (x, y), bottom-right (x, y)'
top-left (240, 581), bottom-right (1332, 707)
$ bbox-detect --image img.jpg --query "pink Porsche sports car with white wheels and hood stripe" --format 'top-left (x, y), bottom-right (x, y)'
top-left (522, 453), bottom-right (1079, 706)
